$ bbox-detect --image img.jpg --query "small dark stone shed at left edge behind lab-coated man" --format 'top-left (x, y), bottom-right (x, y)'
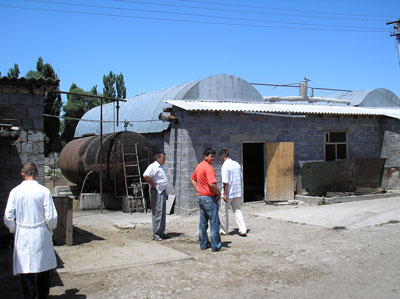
top-left (0, 77), bottom-right (59, 235)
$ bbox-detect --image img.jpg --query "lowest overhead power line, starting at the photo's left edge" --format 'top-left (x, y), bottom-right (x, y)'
top-left (0, 5), bottom-right (387, 33)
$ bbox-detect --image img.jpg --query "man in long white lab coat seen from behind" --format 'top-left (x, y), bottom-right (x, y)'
top-left (4, 162), bottom-right (57, 298)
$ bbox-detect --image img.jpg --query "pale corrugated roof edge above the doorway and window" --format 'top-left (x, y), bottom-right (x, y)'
top-left (166, 100), bottom-right (400, 119)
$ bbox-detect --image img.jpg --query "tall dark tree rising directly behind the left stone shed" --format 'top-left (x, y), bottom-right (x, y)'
top-left (25, 57), bottom-right (62, 155)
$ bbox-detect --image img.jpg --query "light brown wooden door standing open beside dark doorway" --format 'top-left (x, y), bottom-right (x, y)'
top-left (265, 142), bottom-right (294, 202)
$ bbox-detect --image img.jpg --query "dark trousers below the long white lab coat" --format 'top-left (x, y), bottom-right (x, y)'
top-left (21, 269), bottom-right (53, 299)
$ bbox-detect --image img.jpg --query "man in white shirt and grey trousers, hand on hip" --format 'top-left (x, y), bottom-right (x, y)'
top-left (143, 152), bottom-right (168, 241)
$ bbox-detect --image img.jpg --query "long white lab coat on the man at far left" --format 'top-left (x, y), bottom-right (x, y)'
top-left (4, 180), bottom-right (57, 275)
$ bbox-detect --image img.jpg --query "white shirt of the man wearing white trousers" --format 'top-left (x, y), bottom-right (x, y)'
top-left (221, 158), bottom-right (242, 198)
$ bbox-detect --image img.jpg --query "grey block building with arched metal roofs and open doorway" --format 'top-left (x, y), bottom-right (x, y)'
top-left (75, 75), bottom-right (400, 213)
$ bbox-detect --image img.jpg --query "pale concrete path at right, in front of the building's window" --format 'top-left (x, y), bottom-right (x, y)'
top-left (256, 197), bottom-right (400, 228)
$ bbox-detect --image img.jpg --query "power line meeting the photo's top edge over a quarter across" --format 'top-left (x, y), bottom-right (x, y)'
top-left (113, 0), bottom-right (390, 22)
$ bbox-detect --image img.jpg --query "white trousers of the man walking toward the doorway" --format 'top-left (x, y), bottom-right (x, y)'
top-left (219, 197), bottom-right (247, 234)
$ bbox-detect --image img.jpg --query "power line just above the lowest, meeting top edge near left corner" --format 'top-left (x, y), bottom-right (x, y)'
top-left (17, 0), bottom-right (388, 32)
